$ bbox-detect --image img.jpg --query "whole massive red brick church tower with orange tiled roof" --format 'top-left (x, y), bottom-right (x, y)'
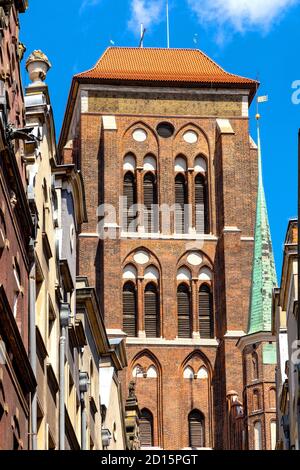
top-left (60, 47), bottom-right (264, 449)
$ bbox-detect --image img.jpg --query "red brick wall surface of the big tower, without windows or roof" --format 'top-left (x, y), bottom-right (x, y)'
top-left (62, 84), bottom-right (257, 449)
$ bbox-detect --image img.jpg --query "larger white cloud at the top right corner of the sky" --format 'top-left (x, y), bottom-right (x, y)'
top-left (187, 0), bottom-right (300, 32)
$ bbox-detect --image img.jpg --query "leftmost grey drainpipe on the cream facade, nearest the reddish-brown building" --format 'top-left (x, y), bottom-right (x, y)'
top-left (29, 238), bottom-right (37, 450)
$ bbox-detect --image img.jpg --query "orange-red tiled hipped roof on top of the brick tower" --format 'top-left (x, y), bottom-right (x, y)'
top-left (75, 47), bottom-right (257, 88)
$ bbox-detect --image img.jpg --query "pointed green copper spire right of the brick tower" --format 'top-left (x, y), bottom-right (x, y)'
top-left (248, 115), bottom-right (277, 334)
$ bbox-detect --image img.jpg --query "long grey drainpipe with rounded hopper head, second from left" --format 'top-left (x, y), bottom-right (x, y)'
top-left (59, 303), bottom-right (70, 450)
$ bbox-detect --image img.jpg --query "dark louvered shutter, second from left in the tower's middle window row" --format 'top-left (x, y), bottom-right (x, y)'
top-left (144, 284), bottom-right (159, 338)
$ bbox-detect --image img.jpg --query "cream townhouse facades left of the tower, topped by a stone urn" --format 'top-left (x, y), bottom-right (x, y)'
top-left (21, 51), bottom-right (127, 450)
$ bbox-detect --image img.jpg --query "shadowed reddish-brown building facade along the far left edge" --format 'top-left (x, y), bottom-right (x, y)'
top-left (0, 0), bottom-right (36, 450)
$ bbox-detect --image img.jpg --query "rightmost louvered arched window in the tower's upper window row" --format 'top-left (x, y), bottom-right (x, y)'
top-left (195, 175), bottom-right (210, 234)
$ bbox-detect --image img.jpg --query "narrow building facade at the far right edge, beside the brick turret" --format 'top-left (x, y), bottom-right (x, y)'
top-left (273, 219), bottom-right (300, 450)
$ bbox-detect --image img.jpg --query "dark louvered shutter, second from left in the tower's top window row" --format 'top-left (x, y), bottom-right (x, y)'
top-left (144, 173), bottom-right (158, 233)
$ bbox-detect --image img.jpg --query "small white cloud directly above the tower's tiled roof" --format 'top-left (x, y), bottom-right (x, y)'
top-left (129, 0), bottom-right (165, 33)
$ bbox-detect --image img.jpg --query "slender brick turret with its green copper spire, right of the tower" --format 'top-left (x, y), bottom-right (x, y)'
top-left (238, 114), bottom-right (277, 450)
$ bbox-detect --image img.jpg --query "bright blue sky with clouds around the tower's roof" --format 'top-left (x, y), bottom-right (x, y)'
top-left (21, 0), bottom-right (300, 277)
